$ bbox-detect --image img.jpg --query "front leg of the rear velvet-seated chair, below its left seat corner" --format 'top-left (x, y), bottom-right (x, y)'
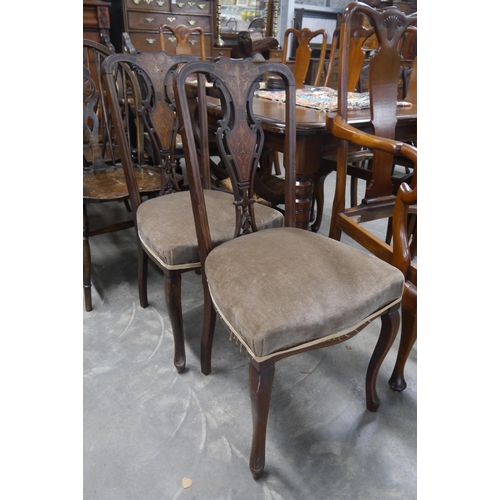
top-left (164, 271), bottom-right (186, 373)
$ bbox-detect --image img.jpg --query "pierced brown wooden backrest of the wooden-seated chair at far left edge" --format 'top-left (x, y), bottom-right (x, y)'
top-left (83, 38), bottom-right (116, 170)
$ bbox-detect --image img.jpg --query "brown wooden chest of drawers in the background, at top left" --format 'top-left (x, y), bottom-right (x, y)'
top-left (123, 0), bottom-right (225, 56)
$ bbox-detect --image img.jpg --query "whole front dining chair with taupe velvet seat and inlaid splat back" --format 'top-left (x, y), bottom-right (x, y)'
top-left (174, 58), bottom-right (406, 479)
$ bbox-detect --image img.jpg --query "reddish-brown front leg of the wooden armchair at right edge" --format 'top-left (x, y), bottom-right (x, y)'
top-left (389, 285), bottom-right (417, 392)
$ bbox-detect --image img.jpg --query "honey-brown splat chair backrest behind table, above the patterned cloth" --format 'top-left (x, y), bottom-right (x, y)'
top-left (283, 28), bottom-right (328, 88)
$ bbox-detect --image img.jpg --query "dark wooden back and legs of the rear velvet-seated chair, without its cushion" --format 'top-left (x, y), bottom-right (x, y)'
top-left (103, 52), bottom-right (198, 372)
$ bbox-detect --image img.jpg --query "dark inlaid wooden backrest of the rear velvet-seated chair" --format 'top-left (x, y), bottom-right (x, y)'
top-left (102, 52), bottom-right (199, 214)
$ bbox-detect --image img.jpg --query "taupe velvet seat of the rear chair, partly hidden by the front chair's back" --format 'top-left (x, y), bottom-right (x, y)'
top-left (137, 190), bottom-right (283, 269)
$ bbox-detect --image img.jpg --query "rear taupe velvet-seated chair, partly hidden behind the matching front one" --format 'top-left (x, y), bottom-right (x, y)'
top-left (103, 52), bottom-right (283, 373)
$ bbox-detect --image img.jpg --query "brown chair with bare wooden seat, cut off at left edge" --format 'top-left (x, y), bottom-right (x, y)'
top-left (83, 39), bottom-right (161, 311)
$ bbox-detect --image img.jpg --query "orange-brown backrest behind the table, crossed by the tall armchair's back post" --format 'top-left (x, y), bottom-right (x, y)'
top-left (324, 25), bottom-right (373, 92)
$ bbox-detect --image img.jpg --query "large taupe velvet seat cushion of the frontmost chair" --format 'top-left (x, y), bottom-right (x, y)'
top-left (206, 228), bottom-right (404, 358)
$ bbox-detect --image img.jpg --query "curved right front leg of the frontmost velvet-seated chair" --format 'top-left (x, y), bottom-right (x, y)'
top-left (366, 304), bottom-right (399, 412)
